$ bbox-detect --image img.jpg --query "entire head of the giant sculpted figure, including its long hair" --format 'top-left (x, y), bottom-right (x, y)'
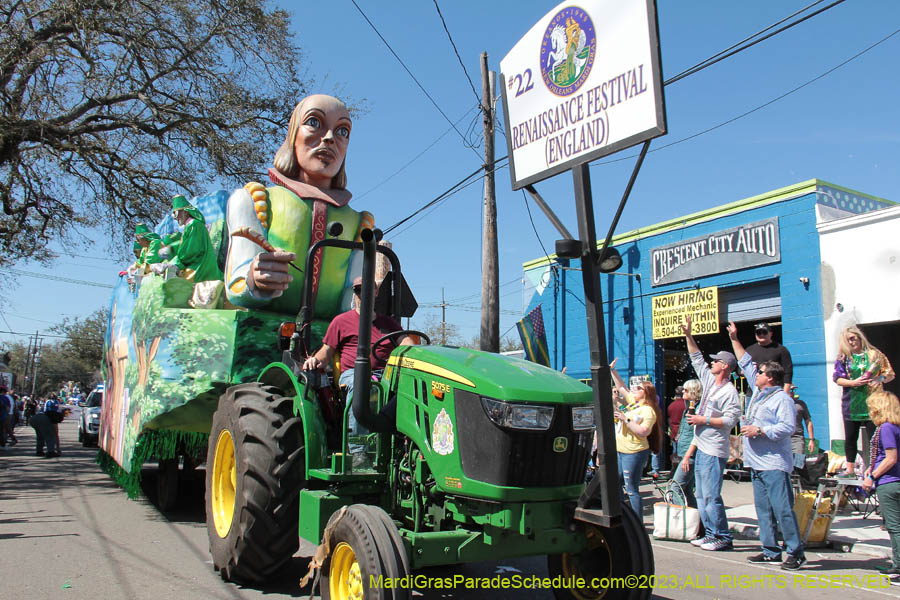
top-left (273, 94), bottom-right (353, 189)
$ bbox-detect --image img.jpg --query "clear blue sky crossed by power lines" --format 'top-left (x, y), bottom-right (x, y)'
top-left (0, 0), bottom-right (900, 350)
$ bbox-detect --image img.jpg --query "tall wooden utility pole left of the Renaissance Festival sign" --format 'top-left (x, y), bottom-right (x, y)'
top-left (480, 52), bottom-right (500, 352)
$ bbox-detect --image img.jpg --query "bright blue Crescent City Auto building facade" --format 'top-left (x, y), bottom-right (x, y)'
top-left (523, 179), bottom-right (894, 447)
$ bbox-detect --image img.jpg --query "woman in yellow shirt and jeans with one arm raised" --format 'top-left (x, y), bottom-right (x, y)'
top-left (609, 360), bottom-right (662, 518)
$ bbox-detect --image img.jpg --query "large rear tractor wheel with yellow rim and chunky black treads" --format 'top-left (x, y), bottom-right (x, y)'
top-left (206, 383), bottom-right (306, 583)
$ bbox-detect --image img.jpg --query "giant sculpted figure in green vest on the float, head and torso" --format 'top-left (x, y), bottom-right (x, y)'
top-left (225, 95), bottom-right (374, 319)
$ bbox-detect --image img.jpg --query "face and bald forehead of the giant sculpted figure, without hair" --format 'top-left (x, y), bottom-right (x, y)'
top-left (294, 94), bottom-right (353, 189)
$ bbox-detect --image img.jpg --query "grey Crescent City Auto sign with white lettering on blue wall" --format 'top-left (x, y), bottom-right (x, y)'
top-left (650, 217), bottom-right (781, 286)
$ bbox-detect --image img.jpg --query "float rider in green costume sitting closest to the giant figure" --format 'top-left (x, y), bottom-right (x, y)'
top-left (152, 196), bottom-right (222, 283)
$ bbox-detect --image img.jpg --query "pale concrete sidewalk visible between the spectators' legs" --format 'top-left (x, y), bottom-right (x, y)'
top-left (644, 476), bottom-right (891, 560)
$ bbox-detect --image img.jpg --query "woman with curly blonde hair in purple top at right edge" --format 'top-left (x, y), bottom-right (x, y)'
top-left (863, 391), bottom-right (900, 585)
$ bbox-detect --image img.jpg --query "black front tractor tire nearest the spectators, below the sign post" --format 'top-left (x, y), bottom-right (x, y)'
top-left (547, 504), bottom-right (654, 600)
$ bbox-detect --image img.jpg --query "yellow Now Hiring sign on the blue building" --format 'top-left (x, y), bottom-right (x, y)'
top-left (653, 287), bottom-right (719, 340)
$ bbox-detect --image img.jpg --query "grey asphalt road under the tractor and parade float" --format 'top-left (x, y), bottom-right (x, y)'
top-left (0, 413), bottom-right (898, 600)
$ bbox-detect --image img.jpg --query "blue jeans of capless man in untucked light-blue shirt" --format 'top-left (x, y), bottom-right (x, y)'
top-left (751, 469), bottom-right (803, 558)
